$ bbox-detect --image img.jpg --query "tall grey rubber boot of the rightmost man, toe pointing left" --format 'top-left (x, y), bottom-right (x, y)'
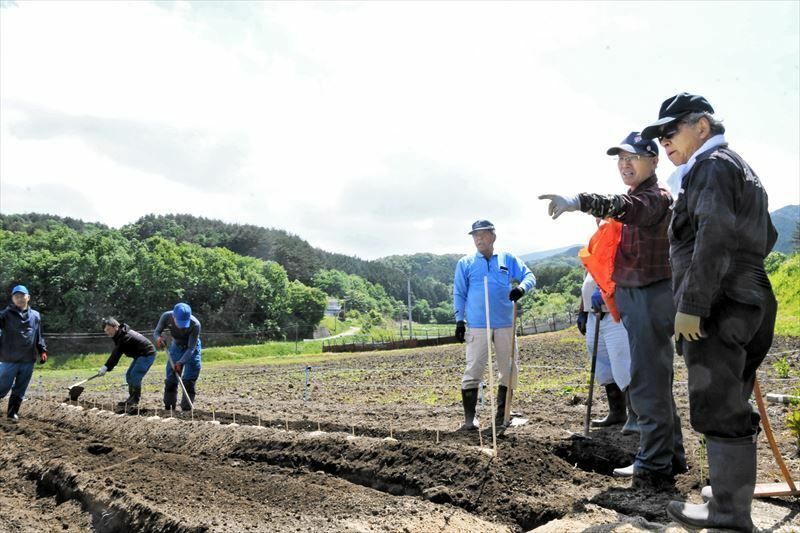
top-left (667, 435), bottom-right (757, 532)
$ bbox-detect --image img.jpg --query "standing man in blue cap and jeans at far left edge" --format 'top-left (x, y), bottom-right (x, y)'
top-left (0, 285), bottom-right (47, 422)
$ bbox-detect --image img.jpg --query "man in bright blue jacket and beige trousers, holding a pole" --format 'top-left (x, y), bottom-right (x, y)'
top-left (453, 220), bottom-right (536, 431)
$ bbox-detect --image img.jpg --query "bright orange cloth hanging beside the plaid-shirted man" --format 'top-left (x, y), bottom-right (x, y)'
top-left (578, 218), bottom-right (622, 322)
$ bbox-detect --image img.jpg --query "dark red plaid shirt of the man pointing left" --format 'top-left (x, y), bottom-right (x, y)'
top-left (580, 175), bottom-right (672, 287)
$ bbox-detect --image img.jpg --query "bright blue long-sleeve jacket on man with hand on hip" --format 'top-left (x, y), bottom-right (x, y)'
top-left (453, 252), bottom-right (536, 328)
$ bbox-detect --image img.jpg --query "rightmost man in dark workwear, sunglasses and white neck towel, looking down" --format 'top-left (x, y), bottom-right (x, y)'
top-left (642, 93), bottom-right (778, 531)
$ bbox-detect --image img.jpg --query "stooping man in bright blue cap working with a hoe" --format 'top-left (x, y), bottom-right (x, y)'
top-left (153, 302), bottom-right (201, 411)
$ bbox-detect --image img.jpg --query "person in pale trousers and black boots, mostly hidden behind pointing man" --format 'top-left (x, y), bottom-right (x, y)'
top-left (577, 272), bottom-right (639, 435)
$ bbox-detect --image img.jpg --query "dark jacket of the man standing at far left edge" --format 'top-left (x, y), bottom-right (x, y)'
top-left (0, 304), bottom-right (47, 363)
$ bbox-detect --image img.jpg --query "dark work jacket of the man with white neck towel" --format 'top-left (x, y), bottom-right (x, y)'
top-left (669, 144), bottom-right (778, 317)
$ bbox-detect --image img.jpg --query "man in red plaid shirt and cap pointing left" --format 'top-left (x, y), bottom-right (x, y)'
top-left (539, 131), bottom-right (687, 489)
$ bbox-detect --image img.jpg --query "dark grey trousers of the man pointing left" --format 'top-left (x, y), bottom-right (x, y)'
top-left (616, 279), bottom-right (686, 475)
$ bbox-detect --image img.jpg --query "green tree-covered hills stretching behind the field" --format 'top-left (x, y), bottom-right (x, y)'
top-left (0, 214), bottom-right (582, 339)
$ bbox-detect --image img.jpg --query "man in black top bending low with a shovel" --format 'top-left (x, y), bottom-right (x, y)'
top-left (97, 317), bottom-right (156, 408)
